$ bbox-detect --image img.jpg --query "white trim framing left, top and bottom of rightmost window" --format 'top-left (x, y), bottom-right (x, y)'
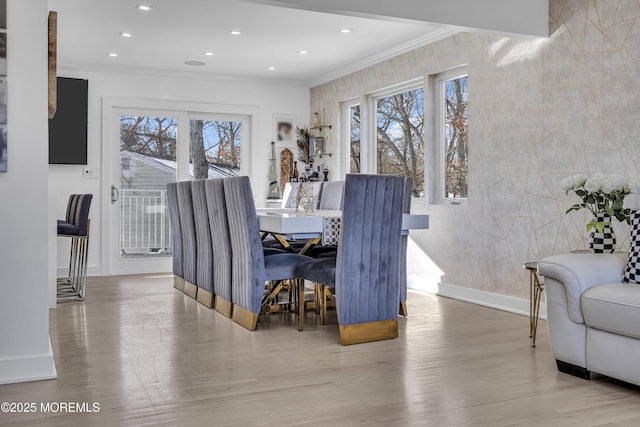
top-left (432, 65), bottom-right (469, 205)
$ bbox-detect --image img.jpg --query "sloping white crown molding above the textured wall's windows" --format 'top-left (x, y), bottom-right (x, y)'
top-left (307, 28), bottom-right (460, 88)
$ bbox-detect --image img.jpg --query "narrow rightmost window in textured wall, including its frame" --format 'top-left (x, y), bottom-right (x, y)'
top-left (435, 68), bottom-right (469, 200)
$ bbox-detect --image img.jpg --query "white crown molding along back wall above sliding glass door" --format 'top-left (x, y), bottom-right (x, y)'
top-left (58, 62), bottom-right (309, 88)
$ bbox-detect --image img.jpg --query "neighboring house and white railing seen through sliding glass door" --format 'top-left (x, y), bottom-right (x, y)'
top-left (120, 151), bottom-right (240, 258)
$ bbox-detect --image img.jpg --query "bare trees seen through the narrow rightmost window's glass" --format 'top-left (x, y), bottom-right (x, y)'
top-left (444, 76), bottom-right (469, 198)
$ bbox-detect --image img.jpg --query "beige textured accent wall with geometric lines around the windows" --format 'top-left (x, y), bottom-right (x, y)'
top-left (311, 0), bottom-right (640, 298)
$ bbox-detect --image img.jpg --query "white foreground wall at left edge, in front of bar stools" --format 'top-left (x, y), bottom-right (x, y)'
top-left (0, 0), bottom-right (56, 386)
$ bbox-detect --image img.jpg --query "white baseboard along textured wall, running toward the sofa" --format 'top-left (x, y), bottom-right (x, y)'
top-left (408, 276), bottom-right (547, 320)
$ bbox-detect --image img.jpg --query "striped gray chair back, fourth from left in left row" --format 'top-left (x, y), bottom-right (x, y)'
top-left (205, 179), bottom-right (232, 302)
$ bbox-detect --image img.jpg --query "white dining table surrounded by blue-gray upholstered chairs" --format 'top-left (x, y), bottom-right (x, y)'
top-left (256, 208), bottom-right (429, 330)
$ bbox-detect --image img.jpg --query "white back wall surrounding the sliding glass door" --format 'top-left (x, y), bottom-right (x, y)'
top-left (49, 69), bottom-right (309, 275)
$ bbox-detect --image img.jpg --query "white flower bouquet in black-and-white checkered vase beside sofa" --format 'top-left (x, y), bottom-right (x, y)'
top-left (561, 173), bottom-right (640, 253)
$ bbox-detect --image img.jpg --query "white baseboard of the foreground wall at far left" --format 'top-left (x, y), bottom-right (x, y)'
top-left (0, 340), bottom-right (58, 384)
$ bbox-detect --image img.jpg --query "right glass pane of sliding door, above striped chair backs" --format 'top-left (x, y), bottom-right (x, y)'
top-left (189, 120), bottom-right (242, 179)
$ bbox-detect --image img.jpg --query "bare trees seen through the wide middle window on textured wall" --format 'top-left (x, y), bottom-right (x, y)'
top-left (377, 89), bottom-right (424, 197)
